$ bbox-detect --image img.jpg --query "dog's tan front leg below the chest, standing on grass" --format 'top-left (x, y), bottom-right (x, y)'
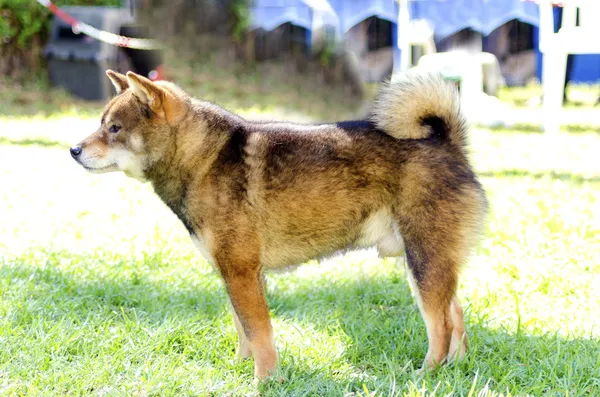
top-left (220, 262), bottom-right (277, 379)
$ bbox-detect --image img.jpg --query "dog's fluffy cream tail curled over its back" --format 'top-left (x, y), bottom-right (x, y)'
top-left (371, 71), bottom-right (467, 150)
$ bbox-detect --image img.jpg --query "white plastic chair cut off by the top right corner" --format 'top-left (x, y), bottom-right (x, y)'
top-left (539, 0), bottom-right (600, 133)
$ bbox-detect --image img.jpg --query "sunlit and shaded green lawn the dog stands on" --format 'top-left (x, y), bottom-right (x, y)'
top-left (0, 76), bottom-right (600, 396)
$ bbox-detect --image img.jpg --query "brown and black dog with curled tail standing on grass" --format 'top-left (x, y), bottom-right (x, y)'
top-left (70, 70), bottom-right (487, 379)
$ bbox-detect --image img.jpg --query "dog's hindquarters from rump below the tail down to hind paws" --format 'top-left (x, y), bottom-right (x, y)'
top-left (393, 158), bottom-right (487, 367)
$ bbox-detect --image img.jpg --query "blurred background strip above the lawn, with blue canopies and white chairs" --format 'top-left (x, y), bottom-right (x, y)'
top-left (0, 0), bottom-right (600, 130)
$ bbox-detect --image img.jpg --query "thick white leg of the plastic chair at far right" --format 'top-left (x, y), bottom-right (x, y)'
top-left (542, 51), bottom-right (567, 134)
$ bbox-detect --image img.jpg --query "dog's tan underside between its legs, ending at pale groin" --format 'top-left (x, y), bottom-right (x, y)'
top-left (261, 209), bottom-right (404, 269)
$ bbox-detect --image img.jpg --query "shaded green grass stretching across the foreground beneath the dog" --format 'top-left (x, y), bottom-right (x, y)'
top-left (0, 253), bottom-right (600, 396)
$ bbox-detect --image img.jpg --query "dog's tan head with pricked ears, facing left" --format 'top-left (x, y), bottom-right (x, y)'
top-left (70, 70), bottom-right (188, 180)
